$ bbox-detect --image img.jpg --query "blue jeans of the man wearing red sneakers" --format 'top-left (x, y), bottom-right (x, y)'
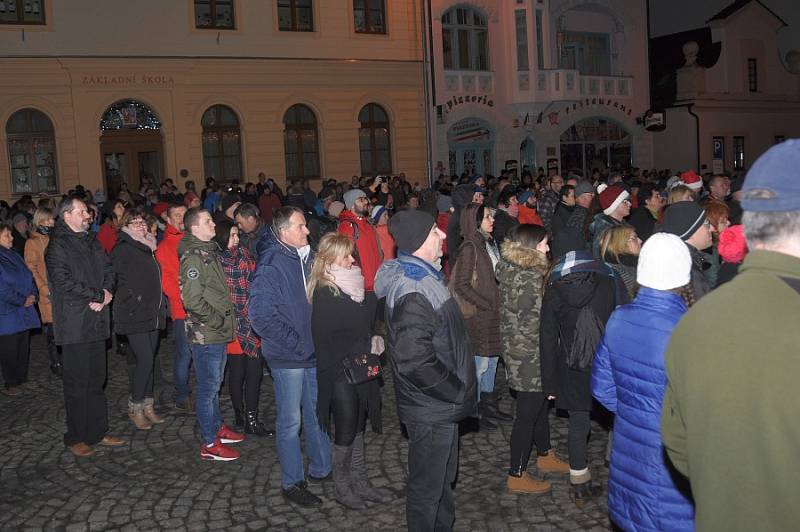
top-left (192, 344), bottom-right (223, 444)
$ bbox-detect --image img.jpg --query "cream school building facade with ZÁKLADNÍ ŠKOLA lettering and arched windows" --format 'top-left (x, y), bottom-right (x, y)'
top-left (0, 0), bottom-right (427, 198)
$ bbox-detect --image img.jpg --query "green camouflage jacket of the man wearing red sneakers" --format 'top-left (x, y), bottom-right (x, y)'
top-left (178, 231), bottom-right (234, 345)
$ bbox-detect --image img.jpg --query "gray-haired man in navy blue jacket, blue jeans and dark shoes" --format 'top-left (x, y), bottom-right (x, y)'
top-left (250, 206), bottom-right (331, 507)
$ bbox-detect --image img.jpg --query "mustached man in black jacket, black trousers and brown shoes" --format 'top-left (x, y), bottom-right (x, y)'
top-left (45, 198), bottom-right (125, 456)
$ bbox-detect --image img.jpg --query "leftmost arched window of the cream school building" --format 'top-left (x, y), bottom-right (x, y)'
top-left (6, 109), bottom-right (58, 194)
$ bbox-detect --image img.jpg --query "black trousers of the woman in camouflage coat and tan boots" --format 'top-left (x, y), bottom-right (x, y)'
top-left (511, 392), bottom-right (550, 471)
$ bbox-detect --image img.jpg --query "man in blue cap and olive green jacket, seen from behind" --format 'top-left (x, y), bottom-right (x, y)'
top-left (661, 139), bottom-right (800, 530)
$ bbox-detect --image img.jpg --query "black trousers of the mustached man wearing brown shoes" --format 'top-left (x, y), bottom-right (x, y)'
top-left (62, 340), bottom-right (108, 445)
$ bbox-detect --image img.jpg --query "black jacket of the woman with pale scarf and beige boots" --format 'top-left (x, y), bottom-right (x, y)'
top-left (111, 231), bottom-right (167, 334)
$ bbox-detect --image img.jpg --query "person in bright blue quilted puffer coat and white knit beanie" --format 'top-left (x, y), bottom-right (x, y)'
top-left (592, 233), bottom-right (694, 531)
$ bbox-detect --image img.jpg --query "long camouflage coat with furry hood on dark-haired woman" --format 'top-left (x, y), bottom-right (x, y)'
top-left (495, 241), bottom-right (547, 392)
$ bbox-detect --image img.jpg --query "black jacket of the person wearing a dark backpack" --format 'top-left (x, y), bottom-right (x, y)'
top-left (539, 272), bottom-right (617, 411)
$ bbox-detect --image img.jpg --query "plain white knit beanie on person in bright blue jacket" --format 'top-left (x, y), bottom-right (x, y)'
top-left (636, 233), bottom-right (692, 290)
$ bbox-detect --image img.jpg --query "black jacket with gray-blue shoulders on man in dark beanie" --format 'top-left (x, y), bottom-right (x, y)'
top-left (375, 254), bottom-right (477, 424)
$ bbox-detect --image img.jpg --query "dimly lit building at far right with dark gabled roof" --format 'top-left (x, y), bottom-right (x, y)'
top-left (652, 0), bottom-right (800, 173)
